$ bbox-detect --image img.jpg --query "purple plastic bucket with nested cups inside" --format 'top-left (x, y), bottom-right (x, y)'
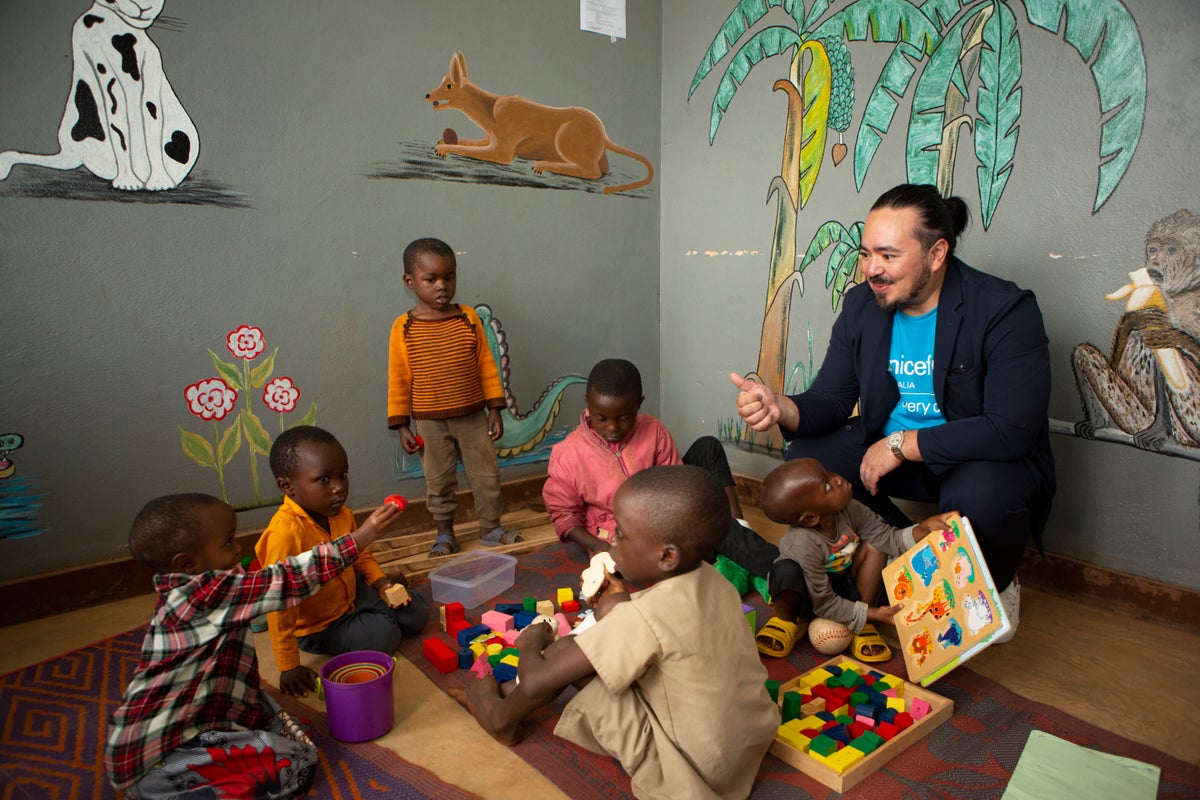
top-left (320, 650), bottom-right (395, 741)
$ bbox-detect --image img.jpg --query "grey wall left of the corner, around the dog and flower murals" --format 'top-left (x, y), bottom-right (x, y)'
top-left (0, 0), bottom-right (661, 579)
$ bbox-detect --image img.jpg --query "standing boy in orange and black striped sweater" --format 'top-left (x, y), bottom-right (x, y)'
top-left (388, 239), bottom-right (521, 557)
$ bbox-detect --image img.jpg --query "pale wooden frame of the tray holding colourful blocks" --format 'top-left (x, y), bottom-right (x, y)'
top-left (770, 656), bottom-right (954, 793)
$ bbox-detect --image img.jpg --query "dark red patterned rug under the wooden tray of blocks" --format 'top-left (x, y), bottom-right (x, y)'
top-left (401, 547), bottom-right (1200, 800)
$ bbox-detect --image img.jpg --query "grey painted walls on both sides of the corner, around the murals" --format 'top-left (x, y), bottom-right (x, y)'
top-left (0, 0), bottom-right (1200, 588)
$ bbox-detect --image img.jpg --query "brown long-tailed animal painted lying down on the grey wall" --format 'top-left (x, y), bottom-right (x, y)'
top-left (425, 52), bottom-right (654, 194)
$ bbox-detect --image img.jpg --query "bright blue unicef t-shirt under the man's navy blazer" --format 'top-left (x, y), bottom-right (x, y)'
top-left (883, 308), bottom-right (946, 433)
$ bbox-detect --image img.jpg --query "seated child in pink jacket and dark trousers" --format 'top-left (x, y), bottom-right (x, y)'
top-left (542, 359), bottom-right (779, 577)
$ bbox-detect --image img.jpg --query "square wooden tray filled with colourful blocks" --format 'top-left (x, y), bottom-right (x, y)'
top-left (770, 656), bottom-right (954, 793)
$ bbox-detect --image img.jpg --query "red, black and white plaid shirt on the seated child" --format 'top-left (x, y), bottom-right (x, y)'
top-left (104, 536), bottom-right (359, 789)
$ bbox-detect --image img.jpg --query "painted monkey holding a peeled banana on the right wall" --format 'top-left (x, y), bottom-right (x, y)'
top-left (1070, 211), bottom-right (1200, 461)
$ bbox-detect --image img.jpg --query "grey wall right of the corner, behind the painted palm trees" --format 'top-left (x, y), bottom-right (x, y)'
top-left (661, 0), bottom-right (1200, 588)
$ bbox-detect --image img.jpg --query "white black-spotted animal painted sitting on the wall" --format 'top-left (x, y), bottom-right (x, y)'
top-left (0, 0), bottom-right (200, 192)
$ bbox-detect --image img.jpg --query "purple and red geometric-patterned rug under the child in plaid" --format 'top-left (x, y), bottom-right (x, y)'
top-left (0, 628), bottom-right (475, 800)
